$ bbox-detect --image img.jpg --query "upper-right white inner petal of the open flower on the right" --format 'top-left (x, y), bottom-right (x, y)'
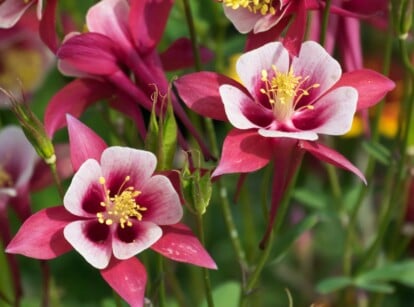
top-left (292, 41), bottom-right (342, 102)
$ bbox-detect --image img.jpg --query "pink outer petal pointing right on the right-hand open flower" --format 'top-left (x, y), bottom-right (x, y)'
top-left (335, 69), bottom-right (395, 110)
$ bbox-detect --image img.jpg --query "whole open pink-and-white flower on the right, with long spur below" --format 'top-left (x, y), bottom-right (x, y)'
top-left (175, 41), bottom-right (394, 247)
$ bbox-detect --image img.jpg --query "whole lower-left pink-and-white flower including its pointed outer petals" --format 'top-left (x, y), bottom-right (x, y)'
top-left (6, 117), bottom-right (216, 306)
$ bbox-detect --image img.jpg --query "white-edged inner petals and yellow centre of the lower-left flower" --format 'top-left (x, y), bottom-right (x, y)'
top-left (64, 147), bottom-right (183, 269)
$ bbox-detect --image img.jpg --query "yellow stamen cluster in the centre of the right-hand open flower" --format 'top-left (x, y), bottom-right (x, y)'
top-left (260, 65), bottom-right (320, 122)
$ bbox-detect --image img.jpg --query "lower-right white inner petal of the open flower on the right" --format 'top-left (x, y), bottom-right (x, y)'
top-left (293, 86), bottom-right (358, 135)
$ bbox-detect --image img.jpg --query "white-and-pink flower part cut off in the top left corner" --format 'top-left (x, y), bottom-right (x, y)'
top-left (0, 0), bottom-right (43, 28)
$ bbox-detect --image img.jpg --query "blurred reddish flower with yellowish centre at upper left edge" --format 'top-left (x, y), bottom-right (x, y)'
top-left (0, 10), bottom-right (54, 108)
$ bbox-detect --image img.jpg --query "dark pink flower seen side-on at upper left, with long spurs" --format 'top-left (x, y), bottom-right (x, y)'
top-left (45, 0), bottom-right (211, 159)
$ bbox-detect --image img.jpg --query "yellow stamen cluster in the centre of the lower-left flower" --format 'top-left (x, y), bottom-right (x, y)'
top-left (96, 176), bottom-right (147, 228)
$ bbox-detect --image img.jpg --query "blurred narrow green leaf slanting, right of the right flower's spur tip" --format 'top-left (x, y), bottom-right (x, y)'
top-left (270, 215), bottom-right (319, 264)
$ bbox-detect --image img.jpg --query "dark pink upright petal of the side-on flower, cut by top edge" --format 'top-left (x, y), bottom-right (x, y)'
top-left (128, 0), bottom-right (174, 54)
